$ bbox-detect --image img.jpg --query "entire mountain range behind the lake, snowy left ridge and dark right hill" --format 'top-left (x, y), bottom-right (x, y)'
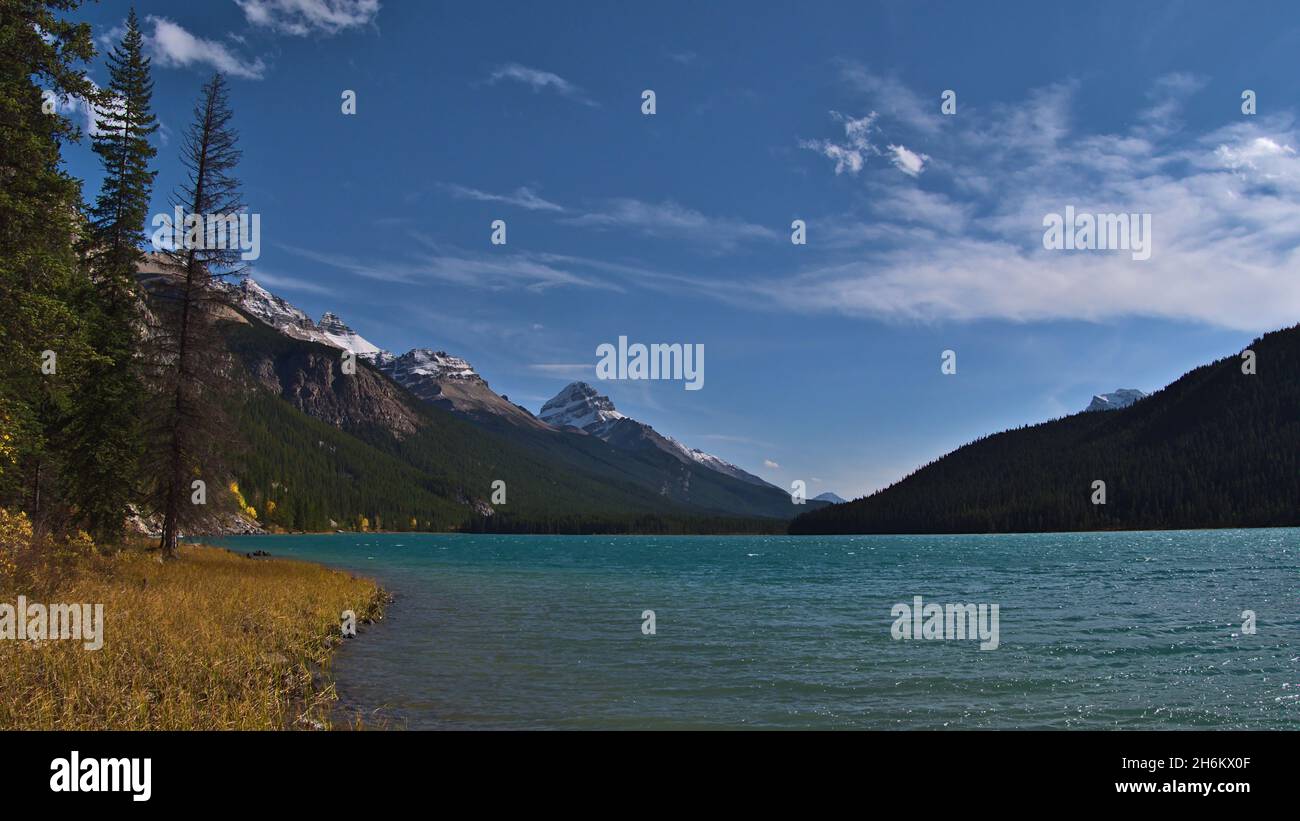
top-left (149, 259), bottom-right (1300, 534)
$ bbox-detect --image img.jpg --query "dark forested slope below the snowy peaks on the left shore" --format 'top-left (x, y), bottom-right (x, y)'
top-left (222, 317), bottom-right (792, 533)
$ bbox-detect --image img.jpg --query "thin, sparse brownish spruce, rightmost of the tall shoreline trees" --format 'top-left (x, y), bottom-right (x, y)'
top-left (147, 73), bottom-right (243, 557)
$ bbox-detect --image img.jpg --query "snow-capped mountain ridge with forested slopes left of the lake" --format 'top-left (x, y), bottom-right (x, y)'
top-left (188, 268), bottom-right (806, 524)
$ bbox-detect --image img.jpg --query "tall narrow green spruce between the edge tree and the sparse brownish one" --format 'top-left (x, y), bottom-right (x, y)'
top-left (65, 9), bottom-right (157, 542)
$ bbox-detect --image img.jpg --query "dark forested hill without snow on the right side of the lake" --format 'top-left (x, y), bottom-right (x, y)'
top-left (790, 325), bottom-right (1300, 534)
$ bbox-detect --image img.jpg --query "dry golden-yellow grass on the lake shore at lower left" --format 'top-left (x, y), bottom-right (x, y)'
top-left (0, 546), bottom-right (384, 730)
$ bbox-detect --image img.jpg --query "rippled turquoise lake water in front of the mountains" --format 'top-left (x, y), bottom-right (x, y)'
top-left (208, 529), bottom-right (1300, 729)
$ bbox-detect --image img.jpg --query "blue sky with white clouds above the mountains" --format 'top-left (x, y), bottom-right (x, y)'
top-left (66, 0), bottom-right (1300, 498)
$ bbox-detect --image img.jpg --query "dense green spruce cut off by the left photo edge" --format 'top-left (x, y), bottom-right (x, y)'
top-left (0, 0), bottom-right (94, 522)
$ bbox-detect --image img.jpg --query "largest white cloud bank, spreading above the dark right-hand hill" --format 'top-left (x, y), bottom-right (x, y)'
top-left (745, 120), bottom-right (1300, 331)
